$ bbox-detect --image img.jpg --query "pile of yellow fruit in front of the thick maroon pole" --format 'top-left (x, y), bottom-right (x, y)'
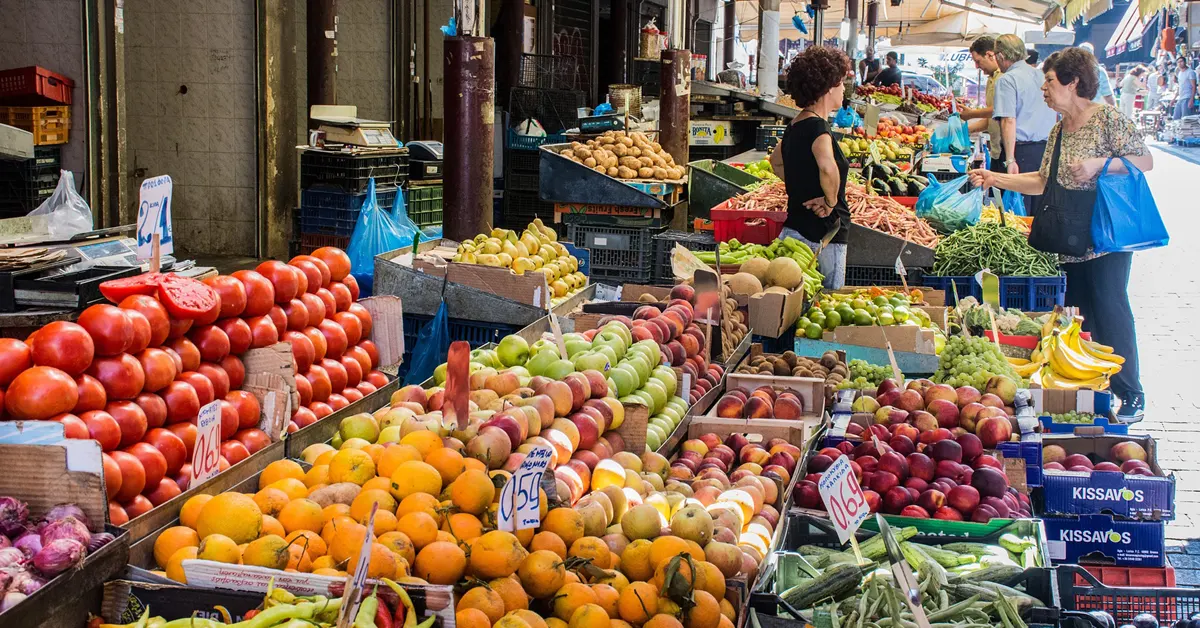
top-left (451, 219), bottom-right (588, 299)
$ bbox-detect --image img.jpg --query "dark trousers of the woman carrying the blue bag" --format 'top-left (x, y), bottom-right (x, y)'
top-left (1062, 253), bottom-right (1142, 396)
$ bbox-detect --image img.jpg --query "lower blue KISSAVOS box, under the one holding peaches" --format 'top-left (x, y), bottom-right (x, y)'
top-left (1042, 515), bottom-right (1166, 567)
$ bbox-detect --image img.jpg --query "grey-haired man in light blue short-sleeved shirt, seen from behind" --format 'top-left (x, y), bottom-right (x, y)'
top-left (991, 35), bottom-right (1058, 215)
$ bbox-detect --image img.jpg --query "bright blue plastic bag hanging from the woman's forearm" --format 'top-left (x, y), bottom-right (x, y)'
top-left (1092, 157), bottom-right (1170, 253)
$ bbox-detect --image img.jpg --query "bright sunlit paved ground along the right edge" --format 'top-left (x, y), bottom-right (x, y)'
top-left (1129, 145), bottom-right (1200, 585)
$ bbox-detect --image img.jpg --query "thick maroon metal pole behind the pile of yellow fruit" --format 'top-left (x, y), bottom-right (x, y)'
top-left (443, 37), bottom-right (496, 241)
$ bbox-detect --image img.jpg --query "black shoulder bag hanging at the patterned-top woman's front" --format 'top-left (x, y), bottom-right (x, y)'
top-left (1030, 126), bottom-right (1096, 257)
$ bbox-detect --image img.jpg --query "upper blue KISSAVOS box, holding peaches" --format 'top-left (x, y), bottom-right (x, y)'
top-left (1042, 435), bottom-right (1175, 520)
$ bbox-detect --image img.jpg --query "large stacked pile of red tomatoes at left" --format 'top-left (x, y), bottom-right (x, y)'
top-left (0, 247), bottom-right (388, 525)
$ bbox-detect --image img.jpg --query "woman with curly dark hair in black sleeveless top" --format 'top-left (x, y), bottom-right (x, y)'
top-left (772, 46), bottom-right (851, 289)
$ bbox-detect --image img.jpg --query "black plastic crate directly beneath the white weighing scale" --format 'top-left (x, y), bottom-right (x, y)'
top-left (300, 150), bottom-right (408, 193)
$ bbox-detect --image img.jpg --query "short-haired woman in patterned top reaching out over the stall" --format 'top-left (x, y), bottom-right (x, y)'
top-left (971, 48), bottom-right (1154, 423)
